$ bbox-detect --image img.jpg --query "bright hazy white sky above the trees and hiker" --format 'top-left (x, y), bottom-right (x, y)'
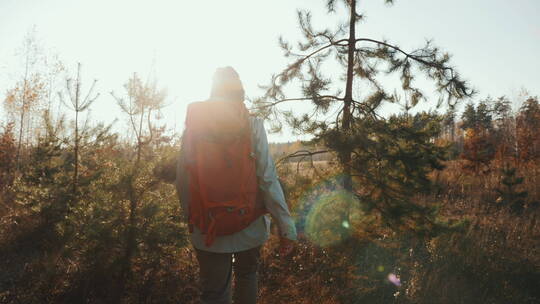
top-left (0, 0), bottom-right (540, 141)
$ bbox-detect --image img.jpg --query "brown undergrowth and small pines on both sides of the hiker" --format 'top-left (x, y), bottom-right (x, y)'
top-left (0, 141), bottom-right (540, 303)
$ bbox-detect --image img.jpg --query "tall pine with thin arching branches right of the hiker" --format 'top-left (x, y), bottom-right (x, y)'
top-left (254, 0), bottom-right (473, 235)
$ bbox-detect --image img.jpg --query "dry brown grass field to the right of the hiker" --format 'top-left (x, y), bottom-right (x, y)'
top-left (261, 161), bottom-right (540, 303)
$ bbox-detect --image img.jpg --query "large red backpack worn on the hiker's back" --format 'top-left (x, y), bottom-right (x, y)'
top-left (183, 101), bottom-right (266, 246)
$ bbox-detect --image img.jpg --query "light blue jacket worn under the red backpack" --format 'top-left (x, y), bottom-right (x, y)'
top-left (176, 117), bottom-right (297, 253)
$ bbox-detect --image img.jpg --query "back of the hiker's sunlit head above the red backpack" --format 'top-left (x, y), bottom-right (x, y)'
top-left (210, 66), bottom-right (244, 101)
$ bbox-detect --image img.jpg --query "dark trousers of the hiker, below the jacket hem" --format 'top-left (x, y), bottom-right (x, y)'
top-left (195, 246), bottom-right (261, 304)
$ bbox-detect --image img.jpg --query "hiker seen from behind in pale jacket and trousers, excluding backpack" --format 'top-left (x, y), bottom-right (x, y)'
top-left (176, 67), bottom-right (296, 304)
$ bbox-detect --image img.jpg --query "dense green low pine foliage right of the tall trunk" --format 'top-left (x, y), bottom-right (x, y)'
top-left (335, 113), bottom-right (448, 234)
